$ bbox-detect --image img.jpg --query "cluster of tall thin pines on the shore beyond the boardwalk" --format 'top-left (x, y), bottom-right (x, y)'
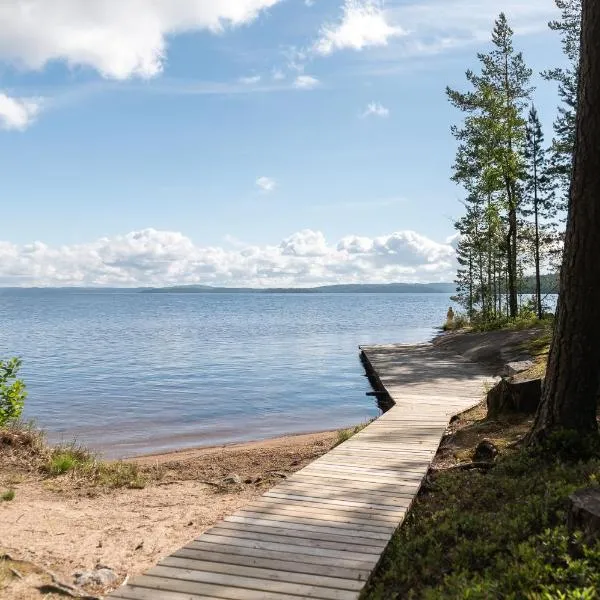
top-left (446, 0), bottom-right (582, 322)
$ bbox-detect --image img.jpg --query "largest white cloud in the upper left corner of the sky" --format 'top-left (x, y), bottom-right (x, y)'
top-left (0, 0), bottom-right (281, 79)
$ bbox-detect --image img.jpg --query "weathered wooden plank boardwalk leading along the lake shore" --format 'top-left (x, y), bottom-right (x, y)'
top-left (111, 344), bottom-right (489, 600)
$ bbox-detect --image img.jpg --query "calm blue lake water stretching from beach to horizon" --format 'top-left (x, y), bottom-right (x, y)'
top-left (0, 290), bottom-right (450, 457)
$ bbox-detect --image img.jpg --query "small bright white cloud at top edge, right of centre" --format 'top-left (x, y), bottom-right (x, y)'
top-left (313, 0), bottom-right (404, 55)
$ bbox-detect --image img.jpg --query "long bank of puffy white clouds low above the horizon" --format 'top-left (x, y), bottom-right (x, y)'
top-left (0, 229), bottom-right (455, 287)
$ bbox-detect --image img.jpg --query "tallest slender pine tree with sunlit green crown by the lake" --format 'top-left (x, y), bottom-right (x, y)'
top-left (446, 14), bottom-right (532, 317)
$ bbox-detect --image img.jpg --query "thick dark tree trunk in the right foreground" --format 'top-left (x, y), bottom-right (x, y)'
top-left (530, 0), bottom-right (600, 443)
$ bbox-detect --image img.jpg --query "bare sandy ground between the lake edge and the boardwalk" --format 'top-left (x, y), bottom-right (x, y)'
top-left (0, 432), bottom-right (336, 600)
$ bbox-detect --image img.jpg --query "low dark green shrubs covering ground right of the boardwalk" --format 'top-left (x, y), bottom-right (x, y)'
top-left (363, 452), bottom-right (600, 600)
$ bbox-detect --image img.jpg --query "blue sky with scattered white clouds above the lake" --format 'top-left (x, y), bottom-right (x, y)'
top-left (0, 0), bottom-right (564, 287)
